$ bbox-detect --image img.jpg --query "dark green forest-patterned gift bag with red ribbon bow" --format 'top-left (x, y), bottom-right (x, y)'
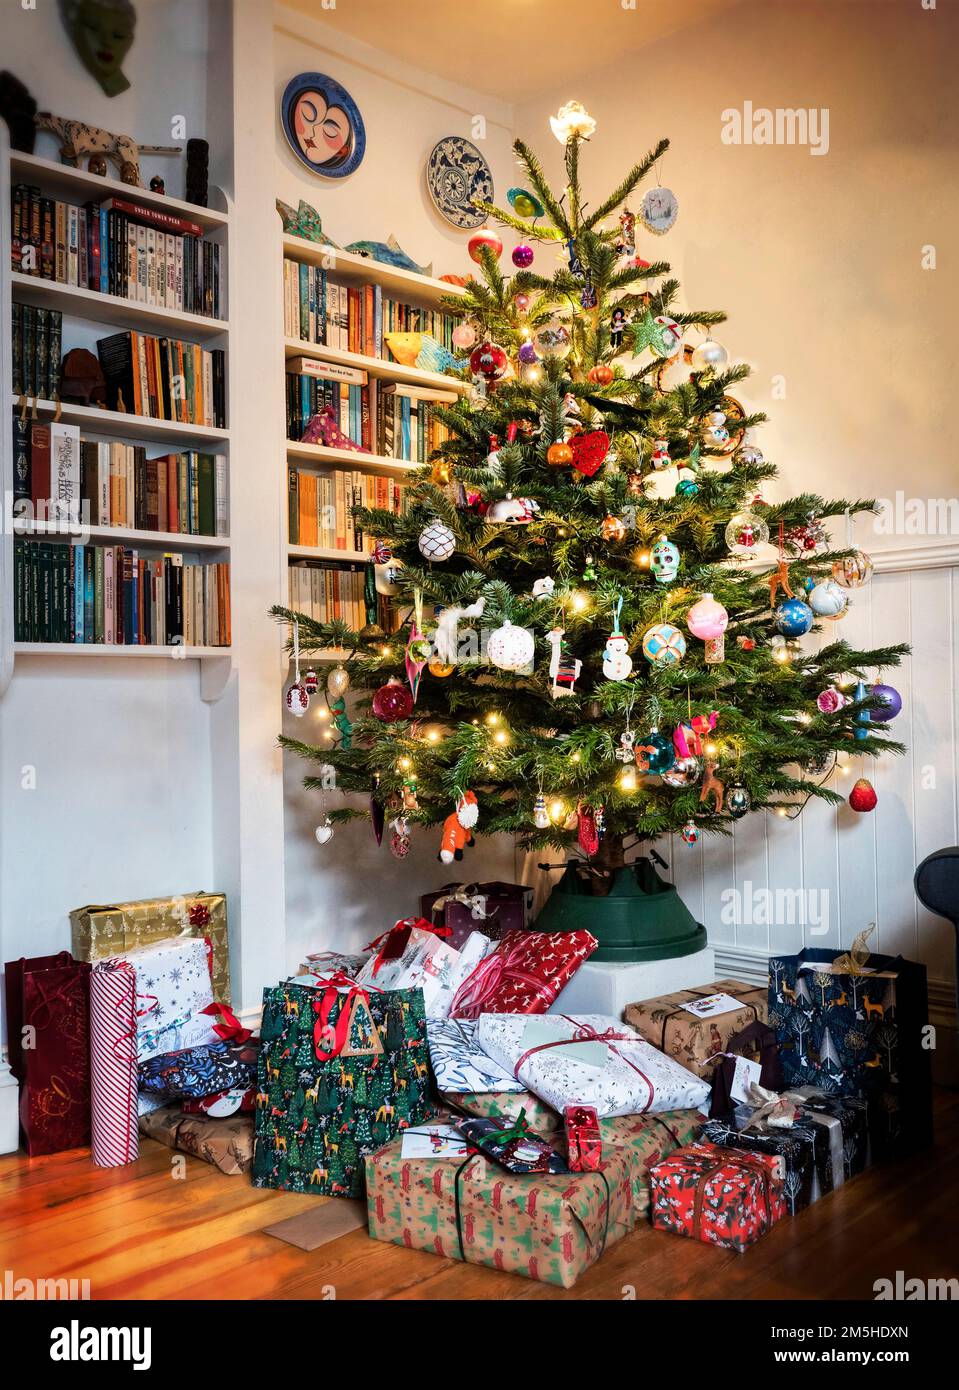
top-left (253, 977), bottom-right (431, 1197)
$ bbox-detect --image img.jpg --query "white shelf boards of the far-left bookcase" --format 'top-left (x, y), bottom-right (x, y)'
top-left (0, 121), bottom-right (232, 701)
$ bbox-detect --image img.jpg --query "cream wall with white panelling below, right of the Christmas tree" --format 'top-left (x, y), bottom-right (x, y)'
top-left (516, 3), bottom-right (959, 1002)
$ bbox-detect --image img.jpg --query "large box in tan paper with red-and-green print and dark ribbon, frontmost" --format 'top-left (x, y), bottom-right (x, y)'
top-left (367, 1140), bottom-right (637, 1289)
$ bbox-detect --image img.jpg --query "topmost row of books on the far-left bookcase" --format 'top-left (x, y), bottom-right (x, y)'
top-left (11, 183), bottom-right (221, 318)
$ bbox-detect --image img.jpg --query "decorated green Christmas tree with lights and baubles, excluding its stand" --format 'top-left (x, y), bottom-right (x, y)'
top-left (274, 103), bottom-right (908, 889)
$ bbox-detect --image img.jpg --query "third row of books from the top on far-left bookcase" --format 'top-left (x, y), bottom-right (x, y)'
top-left (14, 410), bottom-right (229, 537)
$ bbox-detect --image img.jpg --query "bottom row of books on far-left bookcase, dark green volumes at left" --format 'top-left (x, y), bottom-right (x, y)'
top-left (14, 537), bottom-right (231, 646)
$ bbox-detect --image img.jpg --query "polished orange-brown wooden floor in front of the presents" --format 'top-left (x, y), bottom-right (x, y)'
top-left (0, 1091), bottom-right (959, 1300)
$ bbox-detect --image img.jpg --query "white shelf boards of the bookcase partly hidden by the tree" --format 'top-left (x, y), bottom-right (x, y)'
top-left (281, 234), bottom-right (471, 662)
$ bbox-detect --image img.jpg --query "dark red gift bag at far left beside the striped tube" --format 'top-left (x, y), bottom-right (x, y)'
top-left (4, 951), bottom-right (90, 1156)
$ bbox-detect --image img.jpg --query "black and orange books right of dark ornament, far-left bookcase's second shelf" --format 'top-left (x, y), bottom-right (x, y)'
top-left (96, 331), bottom-right (227, 430)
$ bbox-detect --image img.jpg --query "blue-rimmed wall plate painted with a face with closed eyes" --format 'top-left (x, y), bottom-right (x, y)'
top-left (279, 72), bottom-right (367, 178)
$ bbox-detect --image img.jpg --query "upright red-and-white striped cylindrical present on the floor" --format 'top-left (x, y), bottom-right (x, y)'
top-left (90, 960), bottom-right (139, 1168)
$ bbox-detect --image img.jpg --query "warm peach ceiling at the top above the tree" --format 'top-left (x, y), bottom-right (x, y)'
top-left (284, 0), bottom-right (739, 103)
